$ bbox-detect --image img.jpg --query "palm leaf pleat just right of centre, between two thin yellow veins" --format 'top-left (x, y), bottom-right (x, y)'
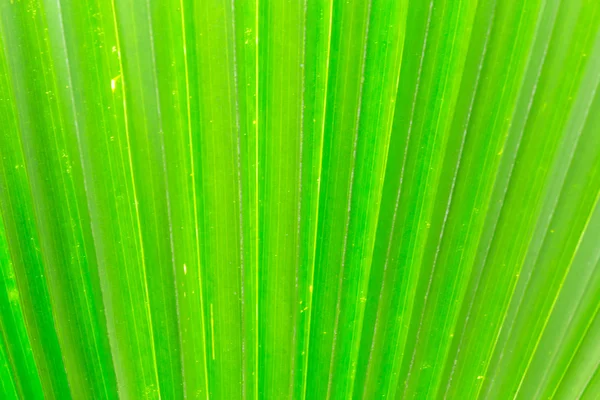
top-left (306, 1), bottom-right (406, 398)
